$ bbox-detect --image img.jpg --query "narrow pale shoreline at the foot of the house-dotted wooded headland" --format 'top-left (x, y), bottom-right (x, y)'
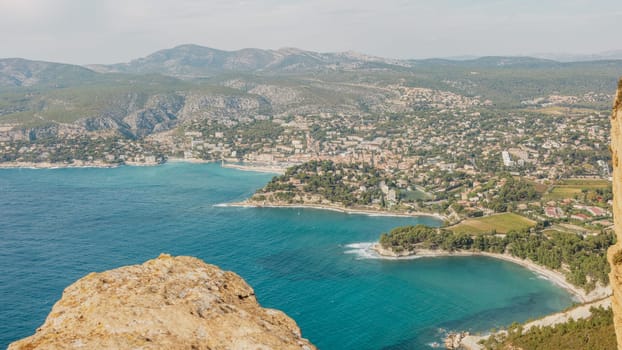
top-left (224, 201), bottom-right (447, 221)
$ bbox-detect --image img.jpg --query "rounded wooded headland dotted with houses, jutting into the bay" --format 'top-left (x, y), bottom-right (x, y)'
top-left (231, 160), bottom-right (447, 220)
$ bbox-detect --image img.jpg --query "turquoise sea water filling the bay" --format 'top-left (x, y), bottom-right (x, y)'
top-left (0, 163), bottom-right (572, 349)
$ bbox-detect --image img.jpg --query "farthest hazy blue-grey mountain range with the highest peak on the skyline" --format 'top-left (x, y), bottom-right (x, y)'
top-left (89, 45), bottom-right (616, 78)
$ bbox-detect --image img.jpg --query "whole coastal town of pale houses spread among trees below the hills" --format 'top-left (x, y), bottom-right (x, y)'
top-left (0, 85), bottom-right (612, 230)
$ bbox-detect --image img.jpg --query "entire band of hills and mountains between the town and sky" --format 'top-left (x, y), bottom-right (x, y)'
top-left (0, 44), bottom-right (622, 140)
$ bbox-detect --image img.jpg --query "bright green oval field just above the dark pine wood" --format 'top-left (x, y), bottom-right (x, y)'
top-left (449, 213), bottom-right (536, 234)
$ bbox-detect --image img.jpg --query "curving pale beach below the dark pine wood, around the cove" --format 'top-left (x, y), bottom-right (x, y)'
top-left (370, 242), bottom-right (611, 303)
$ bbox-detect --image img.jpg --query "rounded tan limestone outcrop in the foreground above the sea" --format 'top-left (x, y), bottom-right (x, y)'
top-left (9, 254), bottom-right (315, 350)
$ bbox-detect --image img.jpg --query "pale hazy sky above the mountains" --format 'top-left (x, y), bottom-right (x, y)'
top-left (0, 0), bottom-right (622, 64)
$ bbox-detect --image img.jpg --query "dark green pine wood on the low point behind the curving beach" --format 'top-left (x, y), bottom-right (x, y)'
top-left (380, 225), bottom-right (614, 291)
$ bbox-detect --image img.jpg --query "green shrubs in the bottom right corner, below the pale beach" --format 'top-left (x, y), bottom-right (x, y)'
top-left (484, 308), bottom-right (617, 350)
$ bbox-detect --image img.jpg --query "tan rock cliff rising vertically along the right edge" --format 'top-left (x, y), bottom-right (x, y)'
top-left (607, 80), bottom-right (622, 350)
